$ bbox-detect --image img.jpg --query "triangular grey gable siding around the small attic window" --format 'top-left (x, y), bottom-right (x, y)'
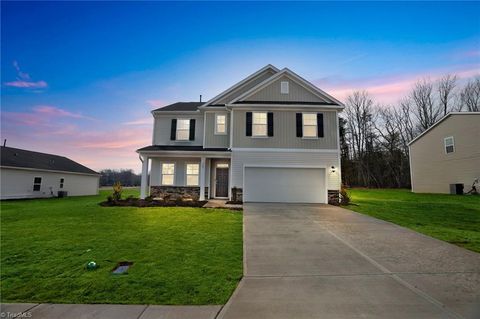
top-left (245, 75), bottom-right (326, 103)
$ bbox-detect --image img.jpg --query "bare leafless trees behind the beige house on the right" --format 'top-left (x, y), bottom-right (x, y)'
top-left (339, 74), bottom-right (480, 188)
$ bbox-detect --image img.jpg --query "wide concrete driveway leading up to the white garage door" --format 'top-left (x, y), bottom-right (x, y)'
top-left (219, 203), bottom-right (480, 319)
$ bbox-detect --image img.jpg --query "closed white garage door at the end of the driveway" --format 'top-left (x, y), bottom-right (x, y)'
top-left (243, 167), bottom-right (327, 203)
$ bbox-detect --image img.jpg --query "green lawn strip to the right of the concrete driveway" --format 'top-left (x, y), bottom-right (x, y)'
top-left (348, 189), bottom-right (480, 252)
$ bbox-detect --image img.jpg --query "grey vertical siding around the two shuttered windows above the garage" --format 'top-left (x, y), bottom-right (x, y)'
top-left (232, 110), bottom-right (338, 149)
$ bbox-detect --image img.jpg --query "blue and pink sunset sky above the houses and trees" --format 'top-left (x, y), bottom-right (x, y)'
top-left (1, 1), bottom-right (480, 172)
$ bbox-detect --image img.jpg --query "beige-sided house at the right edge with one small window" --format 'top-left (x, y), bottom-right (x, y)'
top-left (409, 112), bottom-right (480, 194)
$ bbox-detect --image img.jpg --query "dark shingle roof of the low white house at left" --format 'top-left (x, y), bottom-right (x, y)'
top-left (1, 146), bottom-right (98, 174)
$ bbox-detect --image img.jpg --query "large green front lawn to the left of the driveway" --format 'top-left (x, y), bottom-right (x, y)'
top-left (1, 189), bottom-right (243, 305)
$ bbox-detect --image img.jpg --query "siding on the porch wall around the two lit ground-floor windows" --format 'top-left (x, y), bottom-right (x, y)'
top-left (150, 157), bottom-right (202, 186)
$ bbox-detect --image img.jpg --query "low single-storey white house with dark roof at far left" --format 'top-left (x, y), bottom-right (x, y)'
top-left (0, 146), bottom-right (100, 199)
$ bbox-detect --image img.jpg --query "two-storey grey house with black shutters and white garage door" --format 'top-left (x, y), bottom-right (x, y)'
top-left (137, 65), bottom-right (344, 203)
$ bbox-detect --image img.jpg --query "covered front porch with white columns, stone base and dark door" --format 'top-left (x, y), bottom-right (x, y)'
top-left (139, 149), bottom-right (231, 200)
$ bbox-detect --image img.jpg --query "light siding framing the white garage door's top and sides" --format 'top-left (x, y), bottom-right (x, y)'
top-left (231, 151), bottom-right (341, 190)
